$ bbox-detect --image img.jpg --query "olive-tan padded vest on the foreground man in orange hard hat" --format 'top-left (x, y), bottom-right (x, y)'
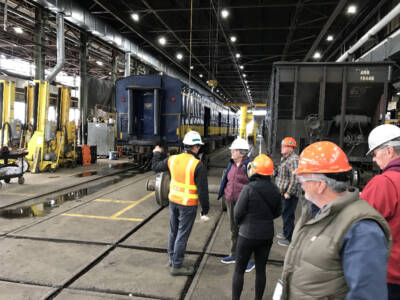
top-left (281, 190), bottom-right (391, 300)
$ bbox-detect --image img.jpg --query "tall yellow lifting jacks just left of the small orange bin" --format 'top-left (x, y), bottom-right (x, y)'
top-left (26, 80), bottom-right (77, 173)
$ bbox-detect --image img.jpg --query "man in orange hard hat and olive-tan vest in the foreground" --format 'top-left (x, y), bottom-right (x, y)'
top-left (274, 141), bottom-right (391, 300)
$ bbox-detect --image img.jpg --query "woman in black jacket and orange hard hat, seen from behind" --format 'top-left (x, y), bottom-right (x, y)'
top-left (232, 154), bottom-right (281, 300)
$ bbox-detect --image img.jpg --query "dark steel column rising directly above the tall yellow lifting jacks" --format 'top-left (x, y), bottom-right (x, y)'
top-left (34, 7), bottom-right (48, 80)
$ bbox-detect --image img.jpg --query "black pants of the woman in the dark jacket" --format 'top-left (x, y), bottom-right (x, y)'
top-left (232, 235), bottom-right (272, 300)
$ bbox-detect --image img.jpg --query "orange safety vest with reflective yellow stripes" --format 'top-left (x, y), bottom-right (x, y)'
top-left (168, 153), bottom-right (200, 206)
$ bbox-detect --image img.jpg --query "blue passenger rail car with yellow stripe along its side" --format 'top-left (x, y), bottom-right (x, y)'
top-left (116, 75), bottom-right (238, 164)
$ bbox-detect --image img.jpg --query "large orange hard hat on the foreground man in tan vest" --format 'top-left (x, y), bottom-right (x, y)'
top-left (294, 141), bottom-right (351, 174)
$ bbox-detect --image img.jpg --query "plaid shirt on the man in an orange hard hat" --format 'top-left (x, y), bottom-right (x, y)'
top-left (275, 152), bottom-right (299, 196)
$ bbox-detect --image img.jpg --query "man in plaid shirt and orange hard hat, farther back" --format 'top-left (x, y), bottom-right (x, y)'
top-left (275, 137), bottom-right (299, 246)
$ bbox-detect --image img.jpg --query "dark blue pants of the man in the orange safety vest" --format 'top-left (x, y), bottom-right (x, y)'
top-left (168, 202), bottom-right (197, 268)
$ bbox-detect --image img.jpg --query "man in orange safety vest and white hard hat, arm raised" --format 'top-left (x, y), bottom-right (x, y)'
top-left (151, 131), bottom-right (210, 276)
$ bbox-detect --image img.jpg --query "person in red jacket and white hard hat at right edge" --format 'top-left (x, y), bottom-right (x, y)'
top-left (361, 124), bottom-right (400, 300)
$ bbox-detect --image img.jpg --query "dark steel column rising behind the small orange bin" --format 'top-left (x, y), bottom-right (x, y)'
top-left (79, 32), bottom-right (88, 145)
